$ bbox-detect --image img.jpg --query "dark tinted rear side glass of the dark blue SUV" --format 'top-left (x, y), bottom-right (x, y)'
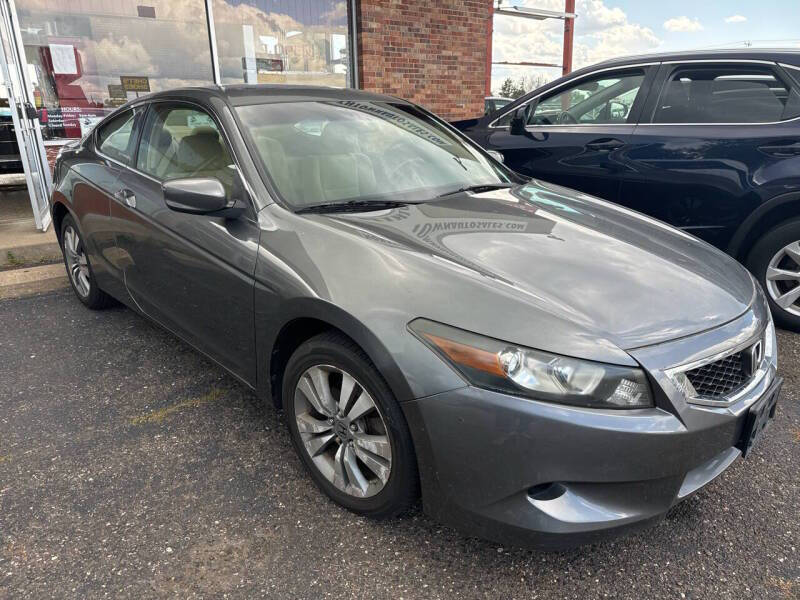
top-left (653, 65), bottom-right (800, 123)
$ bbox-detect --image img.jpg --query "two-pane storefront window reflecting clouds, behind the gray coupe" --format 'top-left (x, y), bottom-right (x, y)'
top-left (16, 0), bottom-right (349, 140)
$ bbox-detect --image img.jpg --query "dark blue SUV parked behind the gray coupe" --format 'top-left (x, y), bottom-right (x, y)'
top-left (454, 50), bottom-right (800, 330)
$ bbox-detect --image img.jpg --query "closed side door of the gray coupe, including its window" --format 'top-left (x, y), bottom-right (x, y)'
top-left (111, 102), bottom-right (259, 383)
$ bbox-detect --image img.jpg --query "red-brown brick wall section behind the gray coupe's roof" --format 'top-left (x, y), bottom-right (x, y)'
top-left (356, 0), bottom-right (492, 120)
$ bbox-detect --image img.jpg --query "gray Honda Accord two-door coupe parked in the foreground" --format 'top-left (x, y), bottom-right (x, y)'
top-left (51, 86), bottom-right (782, 548)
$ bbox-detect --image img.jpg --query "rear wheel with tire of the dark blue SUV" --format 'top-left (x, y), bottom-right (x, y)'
top-left (746, 219), bottom-right (800, 331)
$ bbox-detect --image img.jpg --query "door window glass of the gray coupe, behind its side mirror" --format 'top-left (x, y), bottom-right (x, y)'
top-left (136, 104), bottom-right (235, 191)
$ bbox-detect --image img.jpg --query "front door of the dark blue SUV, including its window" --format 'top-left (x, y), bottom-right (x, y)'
top-left (485, 66), bottom-right (653, 201)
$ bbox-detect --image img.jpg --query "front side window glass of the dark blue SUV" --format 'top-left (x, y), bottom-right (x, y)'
top-left (497, 70), bottom-right (644, 125)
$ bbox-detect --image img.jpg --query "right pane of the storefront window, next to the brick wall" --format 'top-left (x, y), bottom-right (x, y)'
top-left (212, 0), bottom-right (349, 87)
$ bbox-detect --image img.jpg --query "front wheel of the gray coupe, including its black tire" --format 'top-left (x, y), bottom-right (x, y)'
top-left (282, 332), bottom-right (417, 519)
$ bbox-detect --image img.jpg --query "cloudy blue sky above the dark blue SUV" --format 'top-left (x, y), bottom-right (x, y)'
top-left (492, 0), bottom-right (800, 92)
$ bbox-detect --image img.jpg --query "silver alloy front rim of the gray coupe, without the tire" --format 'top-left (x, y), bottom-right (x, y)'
top-left (294, 365), bottom-right (392, 498)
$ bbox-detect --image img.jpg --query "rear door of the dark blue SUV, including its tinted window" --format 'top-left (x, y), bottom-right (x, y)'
top-left (620, 60), bottom-right (800, 249)
